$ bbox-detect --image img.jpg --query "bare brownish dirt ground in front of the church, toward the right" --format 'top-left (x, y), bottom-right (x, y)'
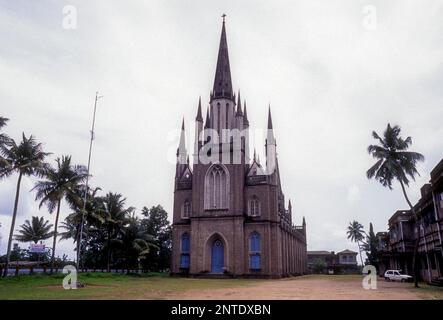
top-left (168, 276), bottom-right (443, 300)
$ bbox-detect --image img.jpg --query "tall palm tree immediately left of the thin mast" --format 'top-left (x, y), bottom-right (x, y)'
top-left (33, 156), bottom-right (87, 272)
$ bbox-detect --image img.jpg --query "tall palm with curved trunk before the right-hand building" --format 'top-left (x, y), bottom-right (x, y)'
top-left (366, 123), bottom-right (425, 287)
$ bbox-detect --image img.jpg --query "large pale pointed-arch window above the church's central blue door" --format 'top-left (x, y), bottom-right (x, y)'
top-left (205, 164), bottom-right (229, 210)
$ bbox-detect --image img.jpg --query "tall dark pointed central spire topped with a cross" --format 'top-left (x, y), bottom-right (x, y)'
top-left (212, 15), bottom-right (233, 99)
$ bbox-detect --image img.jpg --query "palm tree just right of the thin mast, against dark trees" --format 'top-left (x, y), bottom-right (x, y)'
top-left (103, 192), bottom-right (134, 272)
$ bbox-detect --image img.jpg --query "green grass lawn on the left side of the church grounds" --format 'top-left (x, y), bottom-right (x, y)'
top-left (0, 273), bottom-right (258, 300)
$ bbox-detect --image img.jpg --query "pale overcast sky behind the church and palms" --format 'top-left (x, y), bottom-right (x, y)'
top-left (0, 0), bottom-right (443, 255)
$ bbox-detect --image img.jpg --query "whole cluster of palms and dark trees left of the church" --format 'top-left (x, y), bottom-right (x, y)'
top-left (0, 116), bottom-right (172, 276)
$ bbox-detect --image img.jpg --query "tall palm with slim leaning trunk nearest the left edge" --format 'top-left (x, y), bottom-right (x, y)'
top-left (0, 133), bottom-right (49, 276)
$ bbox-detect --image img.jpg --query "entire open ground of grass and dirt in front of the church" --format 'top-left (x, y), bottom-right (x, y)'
top-left (0, 273), bottom-right (443, 300)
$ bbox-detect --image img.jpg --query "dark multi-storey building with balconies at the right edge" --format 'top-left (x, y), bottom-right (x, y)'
top-left (377, 159), bottom-right (443, 283)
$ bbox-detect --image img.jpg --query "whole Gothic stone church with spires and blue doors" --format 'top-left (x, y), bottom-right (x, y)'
top-left (171, 17), bottom-right (307, 278)
